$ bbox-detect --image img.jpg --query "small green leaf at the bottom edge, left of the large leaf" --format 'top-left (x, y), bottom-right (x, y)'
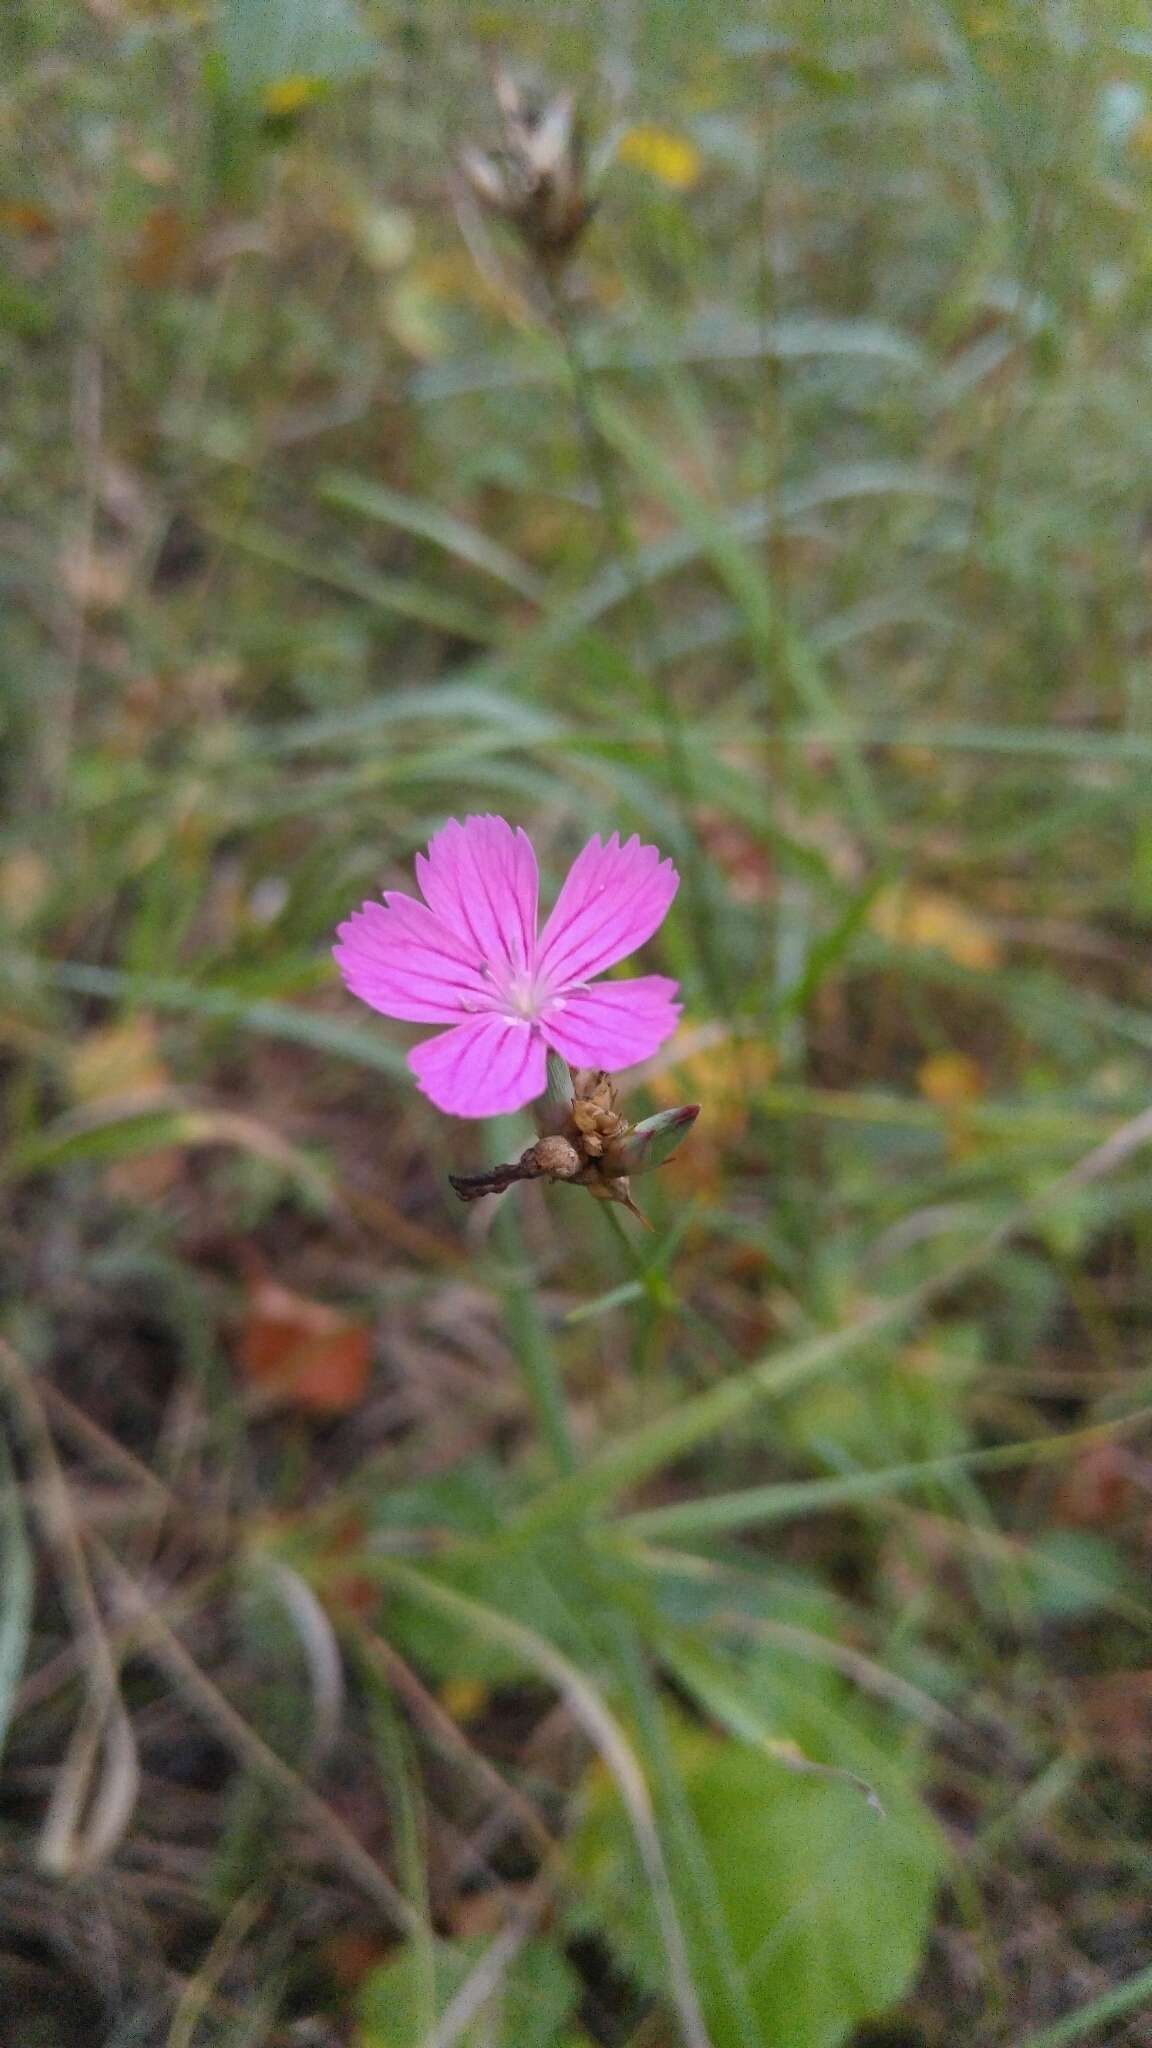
top-left (359, 1942), bottom-right (580, 2048)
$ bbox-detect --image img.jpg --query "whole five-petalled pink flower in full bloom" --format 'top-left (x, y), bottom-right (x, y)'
top-left (332, 817), bottom-right (681, 1116)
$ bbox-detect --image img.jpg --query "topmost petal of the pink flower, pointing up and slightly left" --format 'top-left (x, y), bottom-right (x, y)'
top-left (416, 817), bottom-right (539, 971)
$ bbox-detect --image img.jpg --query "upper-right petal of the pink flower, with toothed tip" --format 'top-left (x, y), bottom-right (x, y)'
top-left (537, 831), bottom-right (681, 989)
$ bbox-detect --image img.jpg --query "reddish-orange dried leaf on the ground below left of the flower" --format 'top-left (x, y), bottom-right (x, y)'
top-left (238, 1280), bottom-right (373, 1415)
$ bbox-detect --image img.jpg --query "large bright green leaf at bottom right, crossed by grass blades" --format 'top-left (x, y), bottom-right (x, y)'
top-left (572, 1729), bottom-right (941, 2048)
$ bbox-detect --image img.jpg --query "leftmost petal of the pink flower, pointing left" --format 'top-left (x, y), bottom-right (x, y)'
top-left (332, 891), bottom-right (494, 1024)
